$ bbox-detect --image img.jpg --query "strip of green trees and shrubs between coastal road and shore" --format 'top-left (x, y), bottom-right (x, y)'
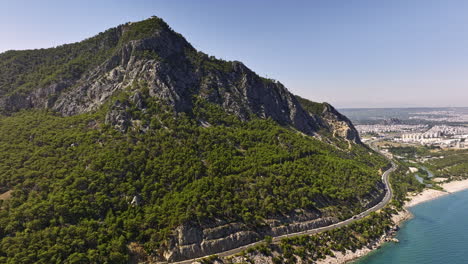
top-left (221, 157), bottom-right (425, 264)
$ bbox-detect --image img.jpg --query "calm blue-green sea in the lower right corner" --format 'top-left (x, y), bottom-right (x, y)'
top-left (354, 191), bottom-right (468, 264)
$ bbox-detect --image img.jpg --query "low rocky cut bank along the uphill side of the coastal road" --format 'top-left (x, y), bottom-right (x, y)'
top-left (163, 183), bottom-right (385, 262)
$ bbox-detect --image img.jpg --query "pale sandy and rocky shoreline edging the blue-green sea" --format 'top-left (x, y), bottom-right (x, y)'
top-left (316, 179), bottom-right (468, 264)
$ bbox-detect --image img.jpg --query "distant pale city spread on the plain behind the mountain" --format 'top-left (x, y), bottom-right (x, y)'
top-left (341, 108), bottom-right (468, 149)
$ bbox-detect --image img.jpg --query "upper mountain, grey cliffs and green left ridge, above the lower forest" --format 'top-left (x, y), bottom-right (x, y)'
top-left (0, 17), bottom-right (359, 142)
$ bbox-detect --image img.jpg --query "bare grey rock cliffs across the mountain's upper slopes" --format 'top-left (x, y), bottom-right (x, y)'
top-left (0, 18), bottom-right (360, 143)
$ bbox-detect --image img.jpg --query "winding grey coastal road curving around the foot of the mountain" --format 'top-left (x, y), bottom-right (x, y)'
top-left (171, 156), bottom-right (397, 264)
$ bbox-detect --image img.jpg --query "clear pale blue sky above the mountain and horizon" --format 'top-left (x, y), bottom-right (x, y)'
top-left (0, 0), bottom-right (468, 107)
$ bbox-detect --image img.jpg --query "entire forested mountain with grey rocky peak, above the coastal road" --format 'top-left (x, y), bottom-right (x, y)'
top-left (0, 17), bottom-right (388, 263)
